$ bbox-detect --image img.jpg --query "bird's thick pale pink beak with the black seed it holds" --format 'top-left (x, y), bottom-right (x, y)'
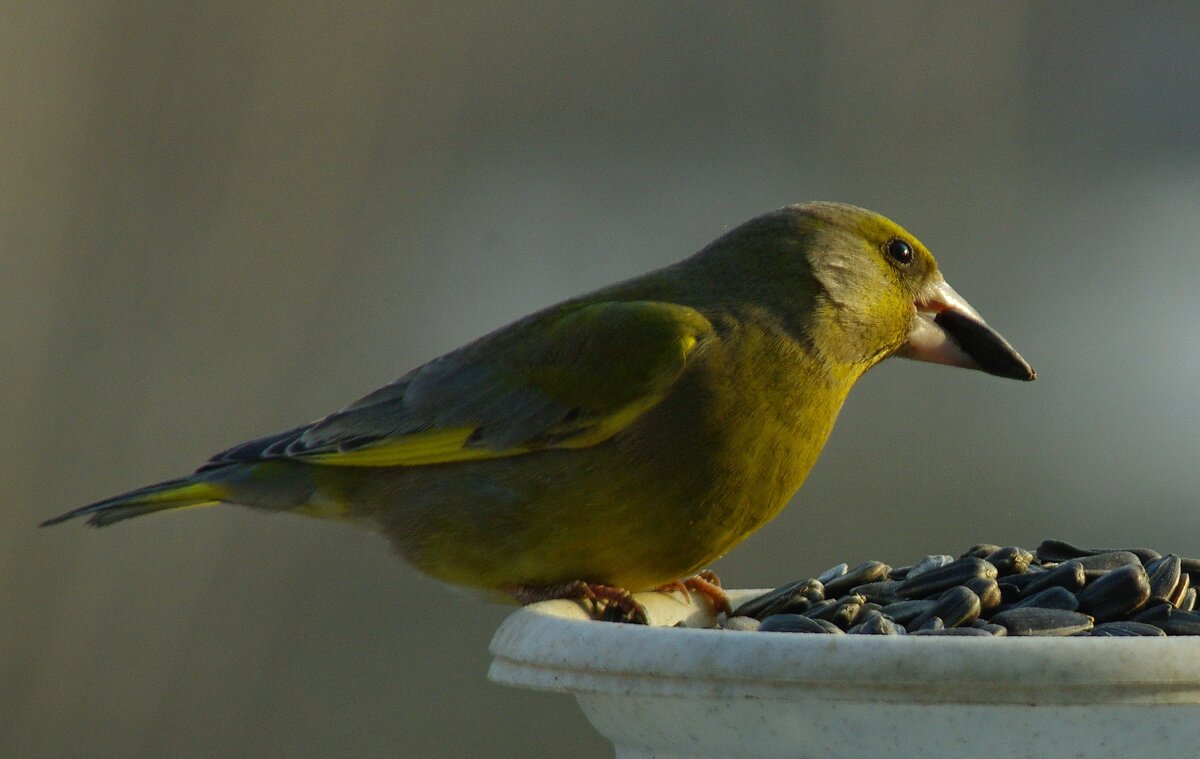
top-left (898, 276), bottom-right (1037, 381)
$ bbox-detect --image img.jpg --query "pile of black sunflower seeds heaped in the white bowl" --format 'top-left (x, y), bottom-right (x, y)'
top-left (721, 540), bottom-right (1200, 637)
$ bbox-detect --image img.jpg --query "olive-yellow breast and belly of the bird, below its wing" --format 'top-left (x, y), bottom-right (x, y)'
top-left (324, 353), bottom-right (845, 591)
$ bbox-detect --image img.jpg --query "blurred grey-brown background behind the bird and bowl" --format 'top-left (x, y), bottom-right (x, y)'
top-left (7, 1), bottom-right (1200, 758)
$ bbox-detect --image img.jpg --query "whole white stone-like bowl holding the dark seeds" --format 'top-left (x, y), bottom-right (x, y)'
top-left (488, 591), bottom-right (1200, 759)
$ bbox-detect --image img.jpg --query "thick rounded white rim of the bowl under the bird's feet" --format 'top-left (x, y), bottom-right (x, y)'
top-left (490, 590), bottom-right (1200, 704)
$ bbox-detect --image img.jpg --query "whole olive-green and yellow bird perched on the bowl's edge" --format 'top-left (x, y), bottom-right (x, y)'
top-left (43, 202), bottom-right (1036, 622)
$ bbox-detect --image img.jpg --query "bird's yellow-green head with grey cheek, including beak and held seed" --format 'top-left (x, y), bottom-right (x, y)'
top-left (779, 203), bottom-right (1036, 380)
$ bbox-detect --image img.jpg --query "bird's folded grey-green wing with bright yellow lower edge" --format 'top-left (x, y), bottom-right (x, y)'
top-left (205, 301), bottom-right (713, 468)
